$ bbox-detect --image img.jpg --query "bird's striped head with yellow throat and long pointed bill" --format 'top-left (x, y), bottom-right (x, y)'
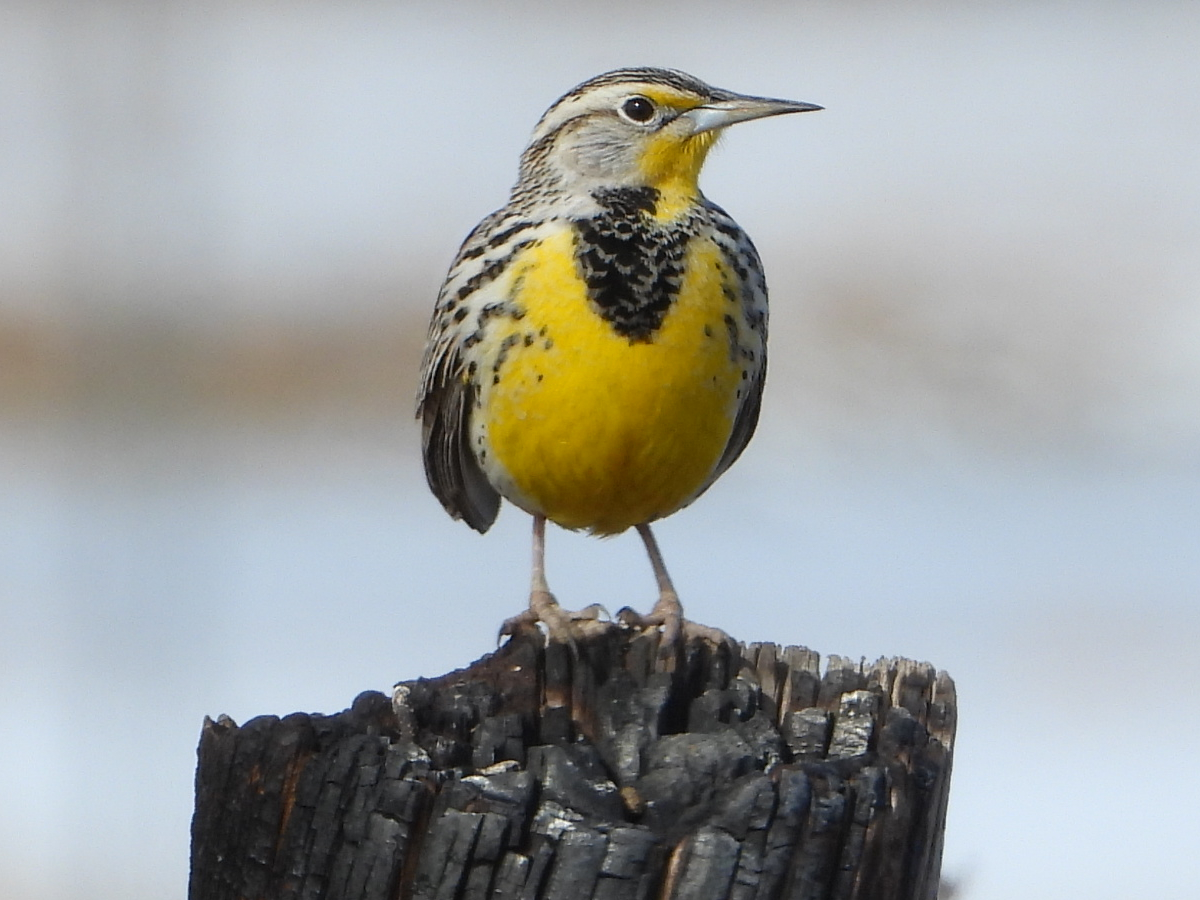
top-left (517, 68), bottom-right (821, 210)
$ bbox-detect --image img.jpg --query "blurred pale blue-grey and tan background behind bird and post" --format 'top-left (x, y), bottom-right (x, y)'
top-left (0, 0), bottom-right (1200, 900)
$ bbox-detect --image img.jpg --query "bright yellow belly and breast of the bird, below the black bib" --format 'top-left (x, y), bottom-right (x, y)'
top-left (476, 230), bottom-right (742, 534)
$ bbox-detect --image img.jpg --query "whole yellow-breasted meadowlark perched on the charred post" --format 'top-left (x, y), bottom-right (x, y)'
top-left (416, 68), bottom-right (821, 648)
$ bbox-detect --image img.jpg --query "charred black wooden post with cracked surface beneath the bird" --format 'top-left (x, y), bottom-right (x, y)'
top-left (190, 628), bottom-right (956, 900)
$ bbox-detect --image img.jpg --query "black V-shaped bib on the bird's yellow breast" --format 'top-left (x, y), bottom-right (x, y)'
top-left (575, 187), bottom-right (690, 341)
